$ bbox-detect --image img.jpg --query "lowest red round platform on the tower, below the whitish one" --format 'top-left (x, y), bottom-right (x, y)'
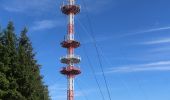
top-left (60, 66), bottom-right (81, 75)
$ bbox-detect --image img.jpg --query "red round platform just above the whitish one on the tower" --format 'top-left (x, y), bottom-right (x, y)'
top-left (61, 40), bottom-right (80, 48)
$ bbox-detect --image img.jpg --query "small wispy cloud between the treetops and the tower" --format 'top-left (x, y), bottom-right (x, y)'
top-left (31, 20), bottom-right (64, 31)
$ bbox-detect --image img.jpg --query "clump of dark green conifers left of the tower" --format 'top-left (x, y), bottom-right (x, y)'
top-left (0, 22), bottom-right (50, 100)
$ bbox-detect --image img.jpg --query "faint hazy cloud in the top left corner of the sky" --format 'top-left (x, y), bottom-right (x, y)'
top-left (0, 0), bottom-right (56, 13)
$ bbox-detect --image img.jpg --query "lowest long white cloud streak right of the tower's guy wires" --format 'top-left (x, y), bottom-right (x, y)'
top-left (105, 61), bottom-right (170, 74)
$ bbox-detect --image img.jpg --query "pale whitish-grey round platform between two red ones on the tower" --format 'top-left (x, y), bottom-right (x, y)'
top-left (60, 55), bottom-right (81, 64)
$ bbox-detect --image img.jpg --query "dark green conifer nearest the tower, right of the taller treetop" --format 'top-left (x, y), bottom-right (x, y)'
top-left (18, 28), bottom-right (48, 100)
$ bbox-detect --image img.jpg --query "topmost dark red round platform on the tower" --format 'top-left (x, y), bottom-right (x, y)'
top-left (61, 5), bottom-right (80, 15)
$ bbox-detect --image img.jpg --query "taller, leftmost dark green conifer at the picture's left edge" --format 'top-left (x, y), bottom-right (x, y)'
top-left (1, 22), bottom-right (24, 100)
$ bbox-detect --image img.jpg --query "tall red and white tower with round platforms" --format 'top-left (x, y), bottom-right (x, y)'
top-left (60, 0), bottom-right (81, 100)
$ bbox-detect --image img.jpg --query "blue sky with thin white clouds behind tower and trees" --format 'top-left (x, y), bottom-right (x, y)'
top-left (0, 0), bottom-right (170, 100)
